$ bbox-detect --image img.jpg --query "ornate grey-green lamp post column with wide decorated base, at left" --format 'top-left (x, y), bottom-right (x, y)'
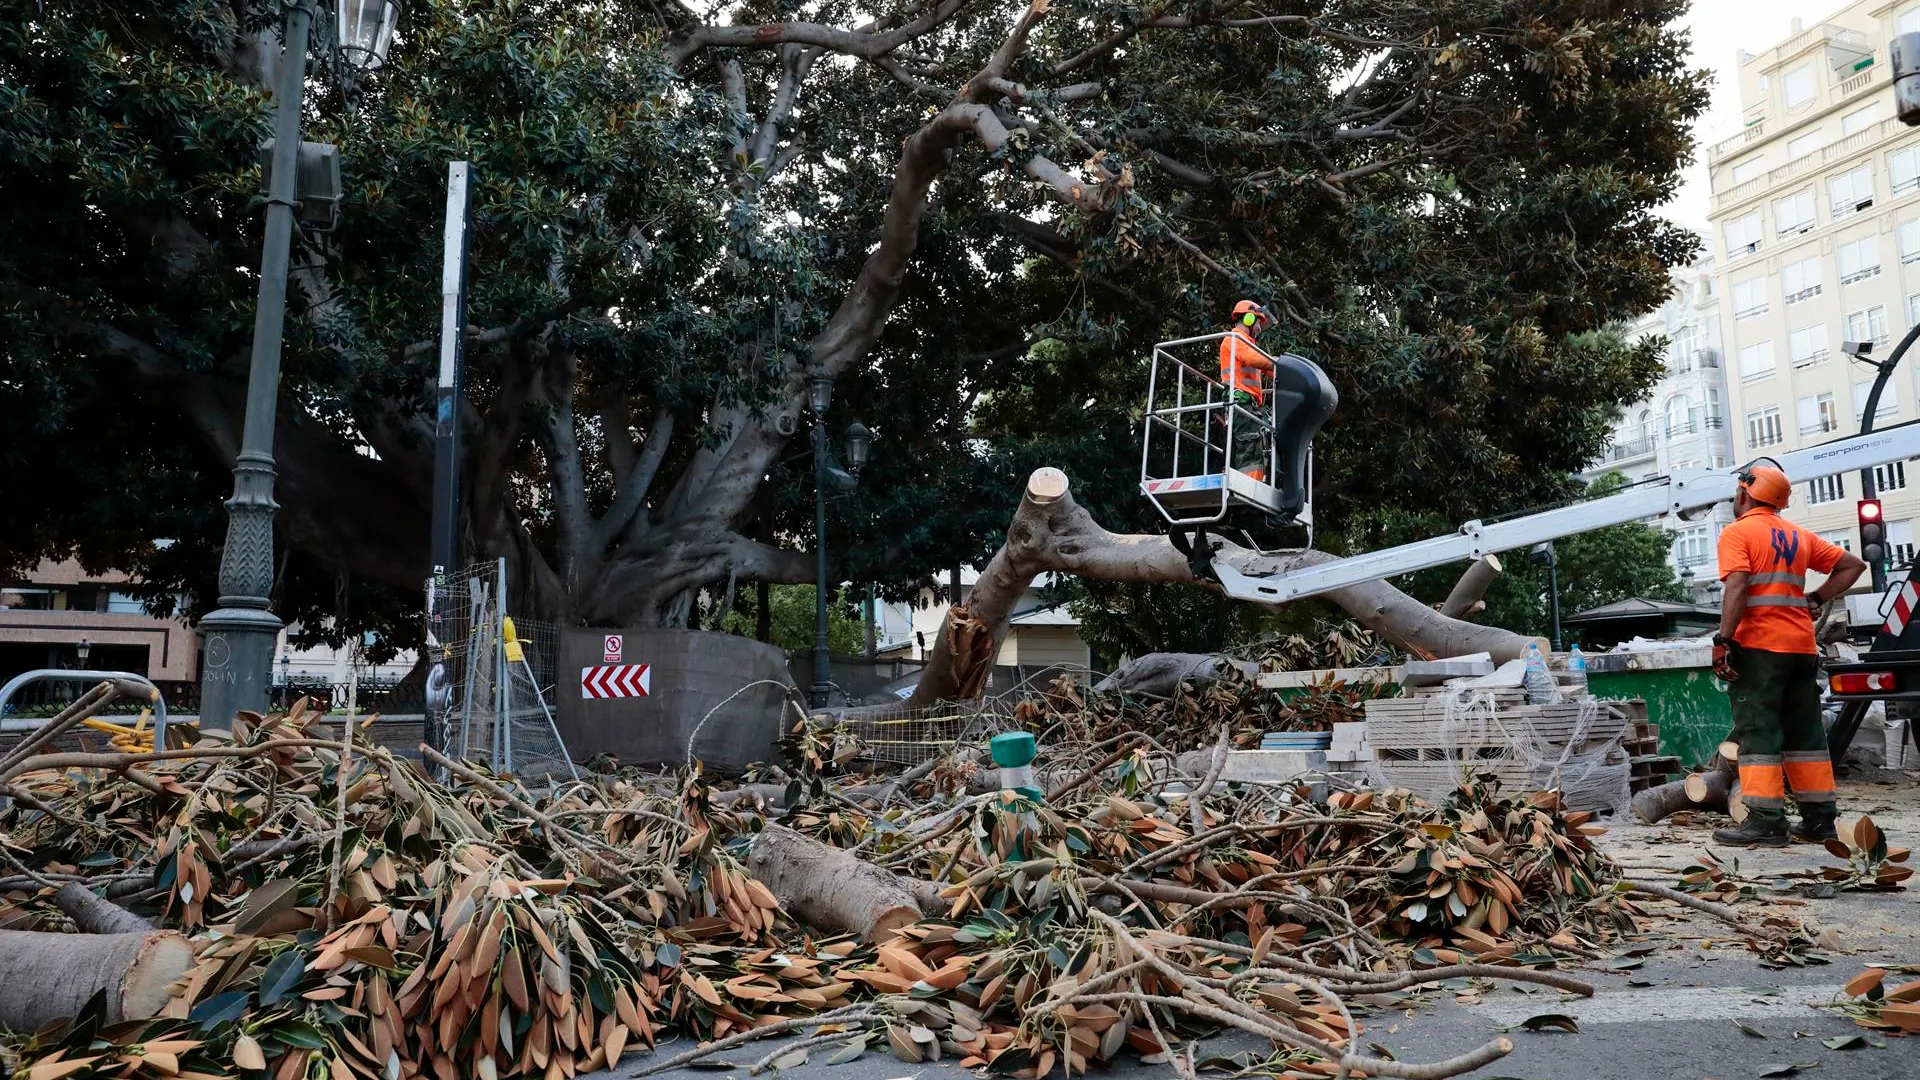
top-left (200, 0), bottom-right (313, 728)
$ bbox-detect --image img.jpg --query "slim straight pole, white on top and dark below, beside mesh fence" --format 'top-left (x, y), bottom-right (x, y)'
top-left (426, 161), bottom-right (472, 749)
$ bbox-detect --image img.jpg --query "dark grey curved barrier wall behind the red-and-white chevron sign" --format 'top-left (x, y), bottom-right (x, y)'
top-left (553, 628), bottom-right (797, 773)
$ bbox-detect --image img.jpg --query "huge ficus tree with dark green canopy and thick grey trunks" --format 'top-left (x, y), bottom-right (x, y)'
top-left (0, 0), bottom-right (1705, 641)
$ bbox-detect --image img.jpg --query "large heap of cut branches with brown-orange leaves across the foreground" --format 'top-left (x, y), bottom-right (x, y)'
top-left (0, 684), bottom-right (1638, 1080)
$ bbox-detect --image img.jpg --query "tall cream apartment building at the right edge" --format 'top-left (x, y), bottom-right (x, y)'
top-left (1707, 0), bottom-right (1920, 567)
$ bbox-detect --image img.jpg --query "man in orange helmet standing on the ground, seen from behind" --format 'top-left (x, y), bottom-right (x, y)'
top-left (1713, 465), bottom-right (1866, 847)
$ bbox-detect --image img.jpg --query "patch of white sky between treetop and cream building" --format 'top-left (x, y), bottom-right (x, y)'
top-left (1667, 0), bottom-right (1850, 236)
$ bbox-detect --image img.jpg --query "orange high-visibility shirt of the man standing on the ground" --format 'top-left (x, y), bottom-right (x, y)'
top-left (1720, 505), bottom-right (1841, 653)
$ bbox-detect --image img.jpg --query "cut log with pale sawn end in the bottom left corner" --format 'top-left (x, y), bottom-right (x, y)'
top-left (0, 930), bottom-right (194, 1032)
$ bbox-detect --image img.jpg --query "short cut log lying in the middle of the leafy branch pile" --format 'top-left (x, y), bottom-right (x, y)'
top-left (747, 824), bottom-right (920, 942)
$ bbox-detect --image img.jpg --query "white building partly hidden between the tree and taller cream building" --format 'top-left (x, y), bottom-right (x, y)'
top-left (1586, 256), bottom-right (1736, 603)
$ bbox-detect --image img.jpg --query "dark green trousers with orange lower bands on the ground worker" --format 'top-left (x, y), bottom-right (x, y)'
top-left (1726, 646), bottom-right (1834, 824)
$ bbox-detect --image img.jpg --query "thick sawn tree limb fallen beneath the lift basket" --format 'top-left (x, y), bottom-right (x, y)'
top-left (889, 469), bottom-right (1538, 709)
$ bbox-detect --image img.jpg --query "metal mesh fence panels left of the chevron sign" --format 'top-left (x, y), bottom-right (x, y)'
top-left (426, 559), bottom-right (578, 776)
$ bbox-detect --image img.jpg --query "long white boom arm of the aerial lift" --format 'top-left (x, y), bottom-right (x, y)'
top-left (1213, 421), bottom-right (1920, 603)
